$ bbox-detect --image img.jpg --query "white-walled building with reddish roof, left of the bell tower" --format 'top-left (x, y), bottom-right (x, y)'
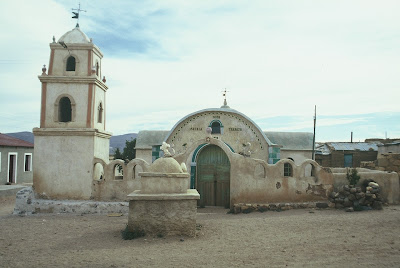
top-left (0, 133), bottom-right (33, 185)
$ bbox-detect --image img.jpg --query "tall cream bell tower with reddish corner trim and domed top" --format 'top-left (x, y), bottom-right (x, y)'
top-left (33, 24), bottom-right (111, 199)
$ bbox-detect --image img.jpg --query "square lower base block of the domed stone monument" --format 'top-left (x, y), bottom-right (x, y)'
top-left (128, 189), bottom-right (200, 236)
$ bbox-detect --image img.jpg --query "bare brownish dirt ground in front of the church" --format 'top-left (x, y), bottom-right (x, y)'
top-left (0, 196), bottom-right (400, 268)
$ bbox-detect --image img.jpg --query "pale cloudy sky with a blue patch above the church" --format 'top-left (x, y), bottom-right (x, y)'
top-left (0, 0), bottom-right (400, 142)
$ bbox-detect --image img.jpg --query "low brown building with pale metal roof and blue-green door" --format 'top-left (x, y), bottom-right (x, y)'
top-left (315, 142), bottom-right (378, 167)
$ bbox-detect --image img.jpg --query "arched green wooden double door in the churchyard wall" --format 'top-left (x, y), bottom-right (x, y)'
top-left (197, 145), bottom-right (231, 208)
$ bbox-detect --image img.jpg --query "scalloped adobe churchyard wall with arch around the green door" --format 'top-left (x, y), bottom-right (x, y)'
top-left (91, 138), bottom-right (399, 205)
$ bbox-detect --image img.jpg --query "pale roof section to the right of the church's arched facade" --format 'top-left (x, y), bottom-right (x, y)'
top-left (264, 131), bottom-right (313, 151)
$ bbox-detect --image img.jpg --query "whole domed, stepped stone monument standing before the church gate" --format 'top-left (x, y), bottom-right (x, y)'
top-left (128, 143), bottom-right (200, 236)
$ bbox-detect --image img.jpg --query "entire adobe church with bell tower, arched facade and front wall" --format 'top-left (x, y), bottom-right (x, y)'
top-left (33, 25), bottom-right (398, 208)
